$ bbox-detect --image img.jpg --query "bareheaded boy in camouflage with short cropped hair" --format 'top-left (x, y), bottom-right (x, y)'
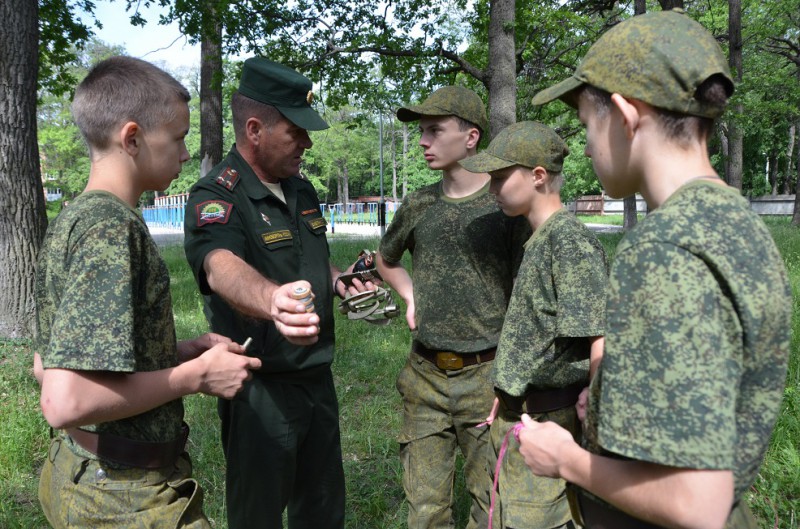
top-left (34, 57), bottom-right (261, 529)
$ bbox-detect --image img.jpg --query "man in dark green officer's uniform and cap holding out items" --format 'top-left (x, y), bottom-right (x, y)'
top-left (184, 57), bottom-right (372, 529)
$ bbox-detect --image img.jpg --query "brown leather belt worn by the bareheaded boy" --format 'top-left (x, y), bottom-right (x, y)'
top-left (65, 423), bottom-right (189, 469)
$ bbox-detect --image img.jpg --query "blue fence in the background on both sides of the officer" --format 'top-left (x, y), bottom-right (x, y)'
top-left (142, 193), bottom-right (398, 230)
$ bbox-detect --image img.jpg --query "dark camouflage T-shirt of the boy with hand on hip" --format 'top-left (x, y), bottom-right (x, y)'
top-left (380, 182), bottom-right (530, 352)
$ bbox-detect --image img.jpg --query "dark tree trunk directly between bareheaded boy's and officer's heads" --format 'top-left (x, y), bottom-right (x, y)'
top-left (200, 7), bottom-right (223, 176)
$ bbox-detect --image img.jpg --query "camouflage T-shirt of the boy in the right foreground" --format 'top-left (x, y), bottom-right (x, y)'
top-left (586, 181), bottom-right (792, 508)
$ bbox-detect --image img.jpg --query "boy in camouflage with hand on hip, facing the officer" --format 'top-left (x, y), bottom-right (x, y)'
top-left (377, 86), bottom-right (530, 529)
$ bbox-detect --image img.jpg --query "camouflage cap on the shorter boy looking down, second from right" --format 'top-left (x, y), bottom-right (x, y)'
top-left (459, 121), bottom-right (569, 173)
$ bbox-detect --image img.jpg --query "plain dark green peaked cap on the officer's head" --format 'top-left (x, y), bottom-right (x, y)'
top-left (239, 57), bottom-right (328, 130)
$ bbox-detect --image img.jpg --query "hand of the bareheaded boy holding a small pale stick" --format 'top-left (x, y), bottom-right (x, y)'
top-left (193, 343), bottom-right (261, 399)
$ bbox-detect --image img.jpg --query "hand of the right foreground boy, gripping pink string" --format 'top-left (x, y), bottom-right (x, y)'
top-left (519, 413), bottom-right (579, 478)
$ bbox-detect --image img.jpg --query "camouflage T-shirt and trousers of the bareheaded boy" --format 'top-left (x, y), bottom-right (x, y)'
top-left (35, 191), bottom-right (191, 529)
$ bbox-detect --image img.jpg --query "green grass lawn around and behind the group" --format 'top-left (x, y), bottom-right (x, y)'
top-left (0, 227), bottom-right (800, 529)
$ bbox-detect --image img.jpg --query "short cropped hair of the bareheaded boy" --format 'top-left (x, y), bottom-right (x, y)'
top-left (72, 56), bottom-right (191, 151)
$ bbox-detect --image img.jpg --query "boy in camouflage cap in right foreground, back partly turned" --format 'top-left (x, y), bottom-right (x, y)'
top-left (521, 11), bottom-right (791, 528)
